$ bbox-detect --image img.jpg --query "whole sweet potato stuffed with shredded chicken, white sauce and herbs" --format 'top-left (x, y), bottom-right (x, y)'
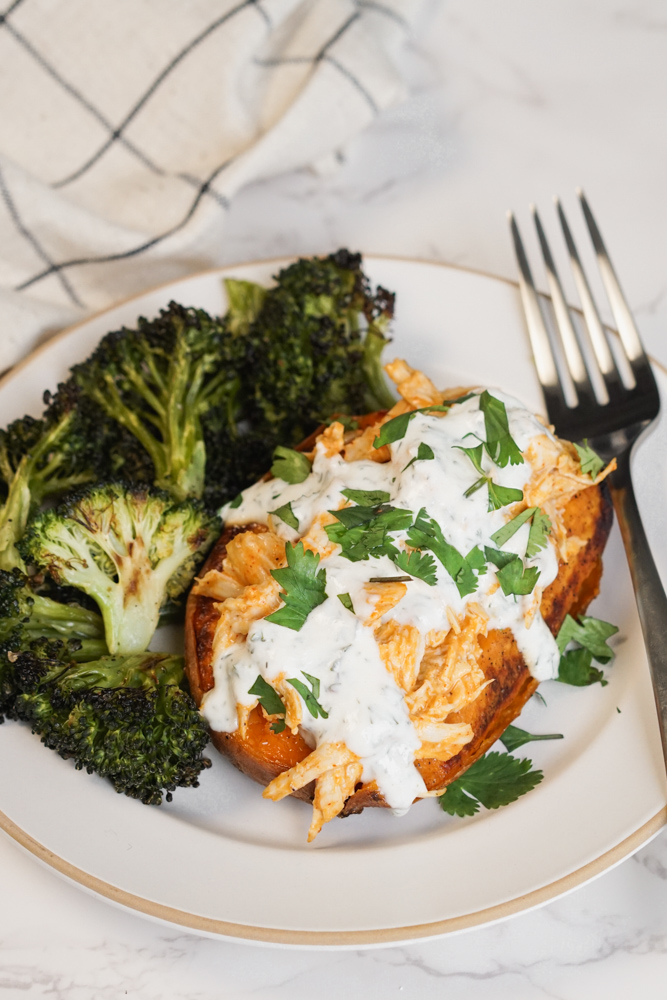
top-left (186, 362), bottom-right (612, 839)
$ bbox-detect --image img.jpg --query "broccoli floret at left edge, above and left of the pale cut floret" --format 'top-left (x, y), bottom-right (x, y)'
top-left (0, 386), bottom-right (99, 570)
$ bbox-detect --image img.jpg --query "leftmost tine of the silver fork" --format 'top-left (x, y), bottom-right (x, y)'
top-left (507, 212), bottom-right (576, 412)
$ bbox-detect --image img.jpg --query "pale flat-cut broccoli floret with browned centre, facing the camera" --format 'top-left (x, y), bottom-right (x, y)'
top-left (19, 483), bottom-right (220, 654)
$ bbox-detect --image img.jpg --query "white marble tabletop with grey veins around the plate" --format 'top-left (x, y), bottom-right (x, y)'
top-left (0, 0), bottom-right (667, 1000)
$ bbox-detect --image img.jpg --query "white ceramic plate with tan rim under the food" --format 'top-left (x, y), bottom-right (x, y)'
top-left (0, 258), bottom-right (667, 948)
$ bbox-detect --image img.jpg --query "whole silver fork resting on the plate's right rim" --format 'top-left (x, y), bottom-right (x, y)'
top-left (509, 191), bottom-right (667, 767)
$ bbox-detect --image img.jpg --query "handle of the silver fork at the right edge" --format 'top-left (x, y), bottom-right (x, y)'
top-left (609, 451), bottom-right (667, 760)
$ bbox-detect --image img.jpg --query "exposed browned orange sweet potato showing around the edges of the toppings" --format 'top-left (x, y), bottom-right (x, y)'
top-left (186, 458), bottom-right (613, 816)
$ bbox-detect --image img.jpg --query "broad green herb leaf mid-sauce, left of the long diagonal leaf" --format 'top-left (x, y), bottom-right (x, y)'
top-left (324, 504), bottom-right (412, 562)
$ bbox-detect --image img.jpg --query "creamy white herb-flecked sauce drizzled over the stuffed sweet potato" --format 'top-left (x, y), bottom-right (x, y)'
top-left (202, 390), bottom-right (559, 812)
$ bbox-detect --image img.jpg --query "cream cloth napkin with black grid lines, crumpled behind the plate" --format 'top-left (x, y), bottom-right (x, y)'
top-left (0, 0), bottom-right (421, 371)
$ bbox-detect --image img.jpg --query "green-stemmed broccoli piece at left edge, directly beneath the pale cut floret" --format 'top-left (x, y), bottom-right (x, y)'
top-left (0, 569), bottom-right (108, 721)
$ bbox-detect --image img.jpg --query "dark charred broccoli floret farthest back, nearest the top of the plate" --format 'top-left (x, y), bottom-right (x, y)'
top-left (247, 250), bottom-right (394, 436)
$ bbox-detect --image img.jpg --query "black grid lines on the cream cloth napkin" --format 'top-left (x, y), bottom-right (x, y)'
top-left (0, 0), bottom-right (402, 306)
